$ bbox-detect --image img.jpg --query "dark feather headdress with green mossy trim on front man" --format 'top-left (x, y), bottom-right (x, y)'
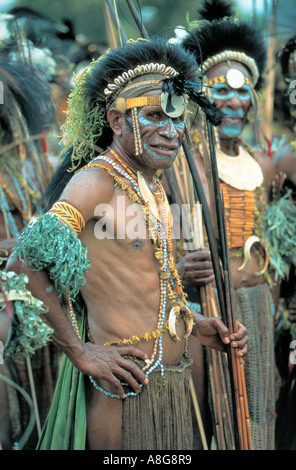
top-left (64, 38), bottom-right (224, 163)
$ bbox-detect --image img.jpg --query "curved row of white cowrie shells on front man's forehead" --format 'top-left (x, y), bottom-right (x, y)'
top-left (104, 63), bottom-right (179, 97)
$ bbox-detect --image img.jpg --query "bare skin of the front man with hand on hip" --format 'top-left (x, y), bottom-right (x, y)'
top-left (9, 90), bottom-right (247, 449)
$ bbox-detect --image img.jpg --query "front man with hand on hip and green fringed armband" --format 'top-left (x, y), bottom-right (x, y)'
top-left (9, 35), bottom-right (246, 450)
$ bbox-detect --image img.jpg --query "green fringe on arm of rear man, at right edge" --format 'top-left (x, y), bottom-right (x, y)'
top-left (263, 192), bottom-right (296, 279)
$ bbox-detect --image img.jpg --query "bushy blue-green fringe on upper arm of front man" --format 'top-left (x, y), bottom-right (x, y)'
top-left (14, 213), bottom-right (90, 300)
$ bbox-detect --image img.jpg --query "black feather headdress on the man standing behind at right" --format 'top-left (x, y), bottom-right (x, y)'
top-left (182, 0), bottom-right (267, 90)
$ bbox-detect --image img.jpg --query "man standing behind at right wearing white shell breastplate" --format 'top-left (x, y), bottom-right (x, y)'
top-left (181, 0), bottom-right (275, 449)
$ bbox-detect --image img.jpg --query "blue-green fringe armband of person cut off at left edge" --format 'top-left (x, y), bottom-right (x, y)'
top-left (0, 271), bottom-right (53, 357)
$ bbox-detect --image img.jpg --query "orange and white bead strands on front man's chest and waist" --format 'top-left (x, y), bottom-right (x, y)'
top-left (74, 149), bottom-right (187, 398)
